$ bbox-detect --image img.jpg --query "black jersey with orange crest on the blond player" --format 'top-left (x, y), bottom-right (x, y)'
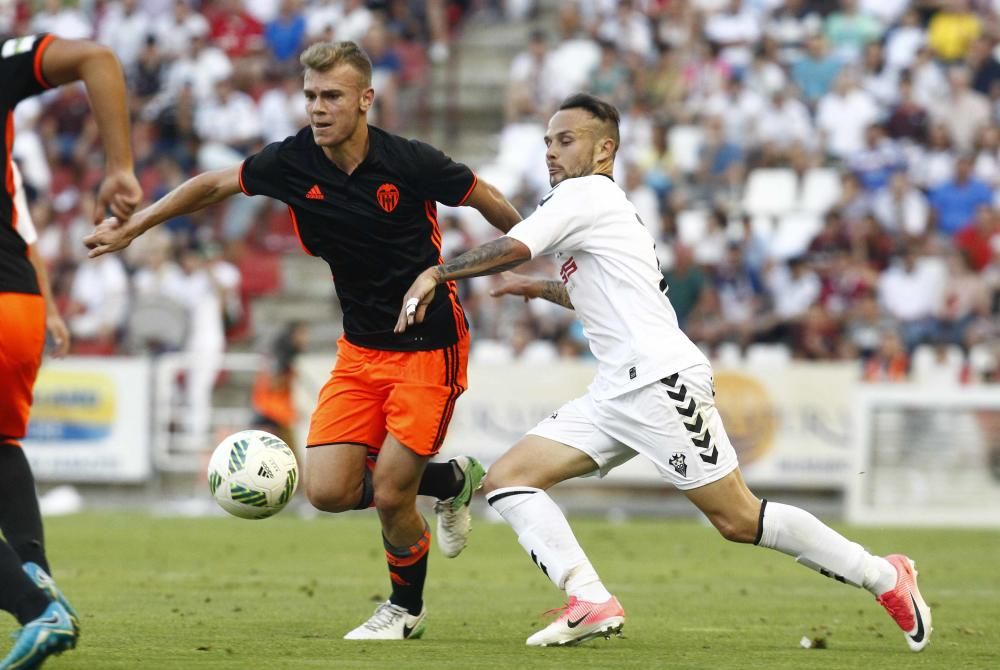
top-left (240, 126), bottom-right (476, 351)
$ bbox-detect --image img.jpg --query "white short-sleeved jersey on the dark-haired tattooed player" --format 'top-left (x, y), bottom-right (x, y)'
top-left (507, 175), bottom-right (709, 399)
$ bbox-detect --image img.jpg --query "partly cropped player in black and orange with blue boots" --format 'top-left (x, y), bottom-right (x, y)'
top-left (0, 33), bottom-right (142, 670)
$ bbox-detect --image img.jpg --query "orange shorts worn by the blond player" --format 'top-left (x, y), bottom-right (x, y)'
top-left (306, 335), bottom-right (469, 456)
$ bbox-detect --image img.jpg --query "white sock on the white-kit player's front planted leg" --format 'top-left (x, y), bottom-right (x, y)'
top-left (486, 486), bottom-right (611, 603)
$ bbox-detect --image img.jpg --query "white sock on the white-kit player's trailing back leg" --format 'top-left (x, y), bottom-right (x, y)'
top-left (755, 500), bottom-right (896, 596)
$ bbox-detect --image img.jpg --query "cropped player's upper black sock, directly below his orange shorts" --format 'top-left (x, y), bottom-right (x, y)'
top-left (0, 440), bottom-right (52, 575)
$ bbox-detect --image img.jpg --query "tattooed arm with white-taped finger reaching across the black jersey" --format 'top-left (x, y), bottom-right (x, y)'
top-left (393, 237), bottom-right (531, 333)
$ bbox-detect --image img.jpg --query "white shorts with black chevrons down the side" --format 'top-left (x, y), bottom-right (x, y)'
top-left (528, 365), bottom-right (738, 490)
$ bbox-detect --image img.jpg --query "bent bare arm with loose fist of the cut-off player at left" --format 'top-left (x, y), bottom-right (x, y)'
top-left (42, 37), bottom-right (142, 224)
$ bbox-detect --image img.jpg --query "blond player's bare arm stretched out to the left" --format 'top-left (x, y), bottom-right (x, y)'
top-left (83, 165), bottom-right (240, 258)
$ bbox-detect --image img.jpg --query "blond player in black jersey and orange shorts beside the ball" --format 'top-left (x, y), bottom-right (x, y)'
top-left (84, 42), bottom-right (520, 640)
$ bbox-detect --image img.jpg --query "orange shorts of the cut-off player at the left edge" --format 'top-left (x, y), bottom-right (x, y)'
top-left (0, 293), bottom-right (45, 440)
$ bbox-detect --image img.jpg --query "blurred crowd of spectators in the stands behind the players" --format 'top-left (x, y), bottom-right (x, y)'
top-left (0, 0), bottom-right (1000, 383)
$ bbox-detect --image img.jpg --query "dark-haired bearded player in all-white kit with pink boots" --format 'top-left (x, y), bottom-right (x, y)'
top-left (396, 94), bottom-right (931, 651)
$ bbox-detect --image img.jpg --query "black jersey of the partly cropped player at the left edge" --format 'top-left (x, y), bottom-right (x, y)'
top-left (0, 34), bottom-right (53, 294)
